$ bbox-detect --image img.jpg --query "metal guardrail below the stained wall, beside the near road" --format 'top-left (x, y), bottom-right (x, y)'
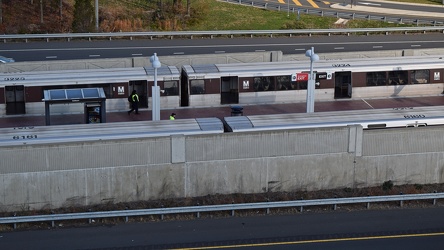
top-left (0, 193), bottom-right (444, 229)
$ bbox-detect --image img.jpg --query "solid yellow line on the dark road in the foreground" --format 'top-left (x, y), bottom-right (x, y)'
top-left (176, 233), bottom-right (444, 250)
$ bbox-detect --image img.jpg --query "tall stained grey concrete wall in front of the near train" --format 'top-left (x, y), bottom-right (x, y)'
top-left (0, 126), bottom-right (444, 211)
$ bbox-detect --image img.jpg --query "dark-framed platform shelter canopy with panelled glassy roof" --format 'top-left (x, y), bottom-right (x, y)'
top-left (42, 88), bottom-right (106, 125)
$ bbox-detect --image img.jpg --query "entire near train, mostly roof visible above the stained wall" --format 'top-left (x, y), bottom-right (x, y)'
top-left (0, 106), bottom-right (444, 148)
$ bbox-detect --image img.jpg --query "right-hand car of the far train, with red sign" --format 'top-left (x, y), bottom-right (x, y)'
top-left (181, 56), bottom-right (444, 106)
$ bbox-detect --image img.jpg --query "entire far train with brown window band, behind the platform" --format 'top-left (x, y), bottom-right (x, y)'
top-left (0, 55), bottom-right (444, 116)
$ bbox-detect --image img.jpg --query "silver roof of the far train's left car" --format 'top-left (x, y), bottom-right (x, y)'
top-left (0, 66), bottom-right (180, 86)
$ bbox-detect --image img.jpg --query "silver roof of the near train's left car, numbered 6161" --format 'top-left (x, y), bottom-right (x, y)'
top-left (0, 118), bottom-right (224, 147)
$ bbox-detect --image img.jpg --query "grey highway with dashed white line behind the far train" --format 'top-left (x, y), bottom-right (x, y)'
top-left (0, 33), bottom-right (444, 62)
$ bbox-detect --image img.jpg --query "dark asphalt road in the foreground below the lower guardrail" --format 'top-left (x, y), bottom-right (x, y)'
top-left (0, 206), bottom-right (444, 250)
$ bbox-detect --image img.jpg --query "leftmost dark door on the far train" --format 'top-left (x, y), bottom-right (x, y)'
top-left (5, 85), bottom-right (26, 115)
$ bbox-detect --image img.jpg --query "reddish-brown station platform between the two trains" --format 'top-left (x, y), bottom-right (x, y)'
top-left (0, 95), bottom-right (444, 128)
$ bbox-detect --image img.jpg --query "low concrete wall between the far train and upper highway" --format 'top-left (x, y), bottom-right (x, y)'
top-left (0, 49), bottom-right (444, 73)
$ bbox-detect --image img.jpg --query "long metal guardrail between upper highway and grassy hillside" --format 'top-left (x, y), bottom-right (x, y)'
top-left (0, 26), bottom-right (444, 43)
